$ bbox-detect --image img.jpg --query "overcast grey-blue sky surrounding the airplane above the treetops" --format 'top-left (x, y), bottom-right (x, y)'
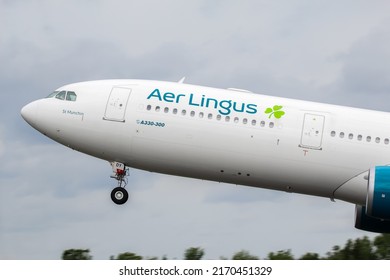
top-left (0, 0), bottom-right (390, 259)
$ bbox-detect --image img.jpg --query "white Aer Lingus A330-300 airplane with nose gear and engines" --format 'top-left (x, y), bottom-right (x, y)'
top-left (21, 78), bottom-right (390, 233)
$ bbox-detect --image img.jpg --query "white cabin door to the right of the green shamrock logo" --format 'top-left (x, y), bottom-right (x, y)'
top-left (299, 113), bottom-right (325, 150)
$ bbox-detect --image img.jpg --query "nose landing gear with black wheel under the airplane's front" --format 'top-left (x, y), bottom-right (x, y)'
top-left (111, 162), bottom-right (129, 205)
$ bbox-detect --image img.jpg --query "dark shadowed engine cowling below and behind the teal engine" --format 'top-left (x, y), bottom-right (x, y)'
top-left (355, 205), bottom-right (390, 233)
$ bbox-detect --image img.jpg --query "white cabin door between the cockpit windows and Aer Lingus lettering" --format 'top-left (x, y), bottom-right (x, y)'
top-left (103, 87), bottom-right (131, 122)
